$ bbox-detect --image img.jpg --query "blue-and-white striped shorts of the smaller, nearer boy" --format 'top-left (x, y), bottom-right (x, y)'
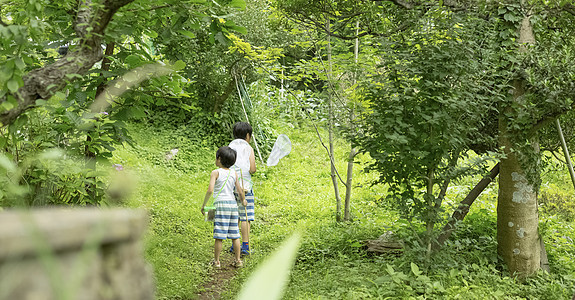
top-left (214, 199), bottom-right (240, 240)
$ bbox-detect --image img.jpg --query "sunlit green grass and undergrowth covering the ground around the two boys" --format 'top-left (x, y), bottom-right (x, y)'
top-left (114, 120), bottom-right (575, 299)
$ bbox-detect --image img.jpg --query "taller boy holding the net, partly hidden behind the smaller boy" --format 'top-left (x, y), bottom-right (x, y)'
top-left (230, 122), bottom-right (256, 255)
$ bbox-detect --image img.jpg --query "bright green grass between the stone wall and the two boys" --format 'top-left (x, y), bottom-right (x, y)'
top-left (114, 126), bottom-right (215, 299)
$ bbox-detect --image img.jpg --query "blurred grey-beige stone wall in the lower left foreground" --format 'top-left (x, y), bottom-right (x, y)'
top-left (0, 208), bottom-right (155, 300)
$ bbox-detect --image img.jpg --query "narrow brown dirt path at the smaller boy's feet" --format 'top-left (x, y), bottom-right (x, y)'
top-left (197, 253), bottom-right (245, 300)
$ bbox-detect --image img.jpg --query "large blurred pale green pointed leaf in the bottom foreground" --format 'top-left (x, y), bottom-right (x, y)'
top-left (238, 233), bottom-right (301, 300)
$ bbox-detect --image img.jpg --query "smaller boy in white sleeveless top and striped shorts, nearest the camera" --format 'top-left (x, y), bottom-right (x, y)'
top-left (201, 147), bottom-right (247, 268)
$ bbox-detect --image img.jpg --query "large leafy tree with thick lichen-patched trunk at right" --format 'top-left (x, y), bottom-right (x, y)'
top-left (274, 0), bottom-right (575, 276)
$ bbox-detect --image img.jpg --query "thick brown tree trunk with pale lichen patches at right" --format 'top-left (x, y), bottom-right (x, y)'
top-left (497, 16), bottom-right (541, 278)
